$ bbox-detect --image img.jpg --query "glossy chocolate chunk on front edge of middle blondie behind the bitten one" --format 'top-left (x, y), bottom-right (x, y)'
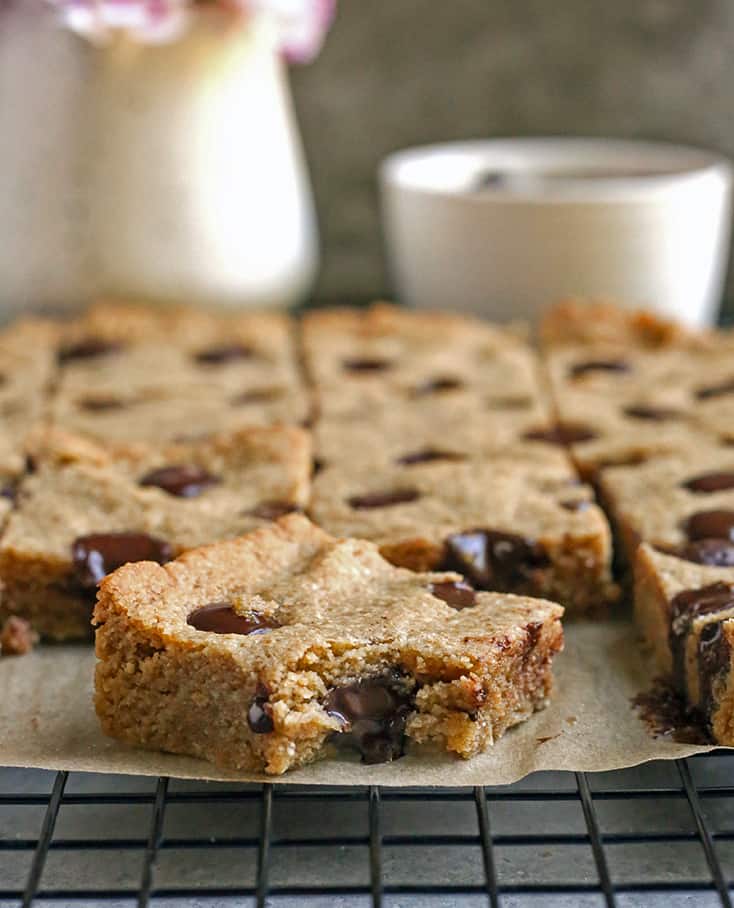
top-left (444, 530), bottom-right (548, 591)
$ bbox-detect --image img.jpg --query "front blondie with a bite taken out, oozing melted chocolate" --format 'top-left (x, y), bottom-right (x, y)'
top-left (94, 515), bottom-right (563, 774)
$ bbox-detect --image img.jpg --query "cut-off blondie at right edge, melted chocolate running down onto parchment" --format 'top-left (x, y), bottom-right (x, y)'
top-left (635, 544), bottom-right (734, 746)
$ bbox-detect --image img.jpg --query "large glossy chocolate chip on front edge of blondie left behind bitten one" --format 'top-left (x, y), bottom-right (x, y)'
top-left (71, 533), bottom-right (173, 589)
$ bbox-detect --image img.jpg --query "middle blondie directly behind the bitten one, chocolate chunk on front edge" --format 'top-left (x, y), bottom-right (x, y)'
top-left (311, 458), bottom-right (617, 610)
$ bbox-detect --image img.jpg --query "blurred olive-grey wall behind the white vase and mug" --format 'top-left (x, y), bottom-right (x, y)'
top-left (292, 0), bottom-right (734, 300)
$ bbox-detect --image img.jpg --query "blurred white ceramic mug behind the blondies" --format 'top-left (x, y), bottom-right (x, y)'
top-left (380, 138), bottom-right (732, 325)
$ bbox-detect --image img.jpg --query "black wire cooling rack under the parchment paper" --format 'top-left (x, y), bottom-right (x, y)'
top-left (0, 751), bottom-right (734, 908)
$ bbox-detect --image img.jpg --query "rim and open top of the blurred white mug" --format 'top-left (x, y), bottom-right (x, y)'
top-left (378, 136), bottom-right (733, 205)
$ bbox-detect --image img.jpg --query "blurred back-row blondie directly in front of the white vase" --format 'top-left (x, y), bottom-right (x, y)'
top-left (51, 304), bottom-right (309, 441)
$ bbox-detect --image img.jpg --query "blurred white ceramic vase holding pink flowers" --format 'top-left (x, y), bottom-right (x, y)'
top-left (0, 5), bottom-right (318, 308)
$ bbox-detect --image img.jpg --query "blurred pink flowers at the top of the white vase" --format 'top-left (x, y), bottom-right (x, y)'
top-left (50, 0), bottom-right (336, 63)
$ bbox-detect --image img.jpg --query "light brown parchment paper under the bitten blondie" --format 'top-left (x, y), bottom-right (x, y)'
top-left (0, 619), bottom-right (724, 786)
